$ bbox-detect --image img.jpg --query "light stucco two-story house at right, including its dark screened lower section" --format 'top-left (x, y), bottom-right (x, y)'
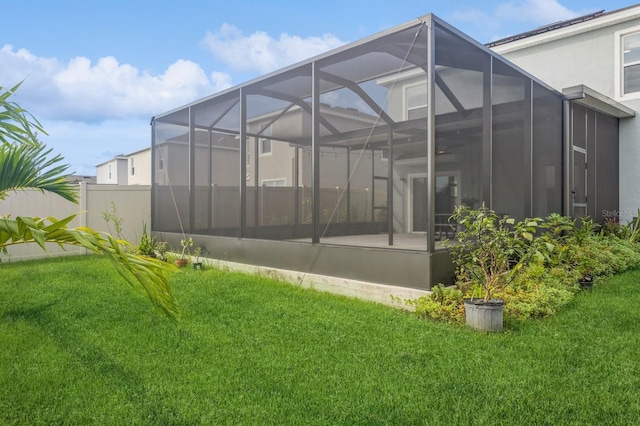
top-left (489, 5), bottom-right (640, 223)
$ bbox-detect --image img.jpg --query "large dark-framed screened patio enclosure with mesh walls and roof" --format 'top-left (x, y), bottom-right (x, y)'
top-left (152, 15), bottom-right (617, 289)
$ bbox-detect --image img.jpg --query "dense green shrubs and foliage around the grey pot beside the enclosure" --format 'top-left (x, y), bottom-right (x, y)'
top-left (411, 206), bottom-right (640, 324)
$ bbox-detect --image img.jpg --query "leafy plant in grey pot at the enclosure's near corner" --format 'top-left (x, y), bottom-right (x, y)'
top-left (447, 205), bottom-right (552, 331)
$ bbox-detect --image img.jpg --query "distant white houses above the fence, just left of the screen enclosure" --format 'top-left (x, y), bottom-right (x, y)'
top-left (96, 148), bottom-right (151, 185)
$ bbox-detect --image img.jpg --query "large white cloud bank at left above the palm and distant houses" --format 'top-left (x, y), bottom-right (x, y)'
top-left (0, 45), bottom-right (231, 121)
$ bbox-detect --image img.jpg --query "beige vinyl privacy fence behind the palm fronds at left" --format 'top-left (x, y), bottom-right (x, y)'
top-left (0, 183), bottom-right (151, 262)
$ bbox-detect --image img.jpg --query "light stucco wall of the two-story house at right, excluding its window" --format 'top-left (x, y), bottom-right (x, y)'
top-left (493, 7), bottom-right (640, 223)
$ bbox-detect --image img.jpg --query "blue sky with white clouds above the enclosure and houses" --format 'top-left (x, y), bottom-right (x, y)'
top-left (0, 0), bottom-right (636, 175)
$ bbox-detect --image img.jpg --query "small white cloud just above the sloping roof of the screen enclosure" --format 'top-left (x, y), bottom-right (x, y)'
top-left (201, 23), bottom-right (345, 73)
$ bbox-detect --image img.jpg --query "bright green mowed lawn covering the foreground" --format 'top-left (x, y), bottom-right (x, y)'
top-left (0, 256), bottom-right (640, 425)
